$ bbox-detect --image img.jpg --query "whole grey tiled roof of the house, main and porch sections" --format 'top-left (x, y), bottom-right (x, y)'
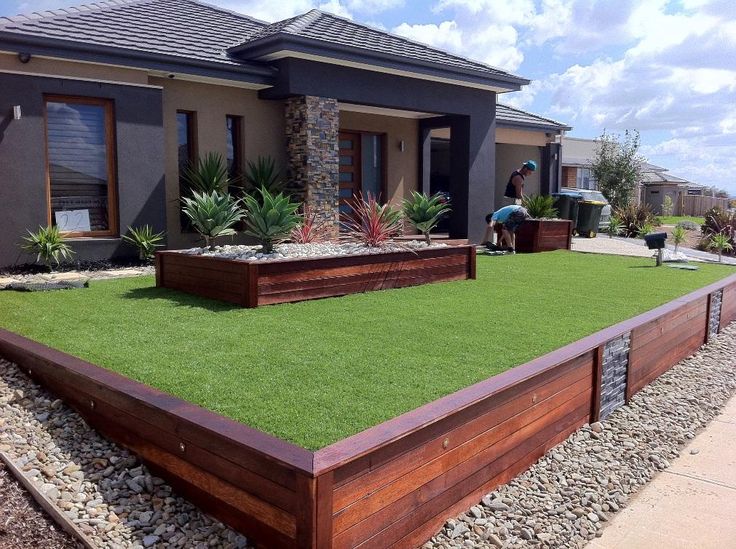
top-left (0, 0), bottom-right (529, 91)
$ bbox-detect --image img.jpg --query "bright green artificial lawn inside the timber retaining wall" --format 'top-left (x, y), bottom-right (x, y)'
top-left (0, 252), bottom-right (736, 450)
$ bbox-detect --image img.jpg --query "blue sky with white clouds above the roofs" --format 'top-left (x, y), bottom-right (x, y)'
top-left (5, 0), bottom-right (736, 195)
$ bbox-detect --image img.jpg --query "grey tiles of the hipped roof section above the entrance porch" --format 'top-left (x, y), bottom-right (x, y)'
top-left (230, 10), bottom-right (524, 80)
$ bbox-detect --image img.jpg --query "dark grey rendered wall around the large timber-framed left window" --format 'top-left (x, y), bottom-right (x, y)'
top-left (0, 73), bottom-right (166, 266)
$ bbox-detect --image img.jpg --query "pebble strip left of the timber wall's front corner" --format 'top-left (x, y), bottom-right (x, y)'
top-left (0, 360), bottom-right (248, 549)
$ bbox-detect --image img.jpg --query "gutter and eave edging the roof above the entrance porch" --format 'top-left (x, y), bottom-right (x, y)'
top-left (227, 33), bottom-right (531, 91)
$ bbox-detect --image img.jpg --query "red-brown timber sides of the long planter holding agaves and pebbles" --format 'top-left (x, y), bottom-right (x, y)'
top-left (156, 246), bottom-right (475, 308)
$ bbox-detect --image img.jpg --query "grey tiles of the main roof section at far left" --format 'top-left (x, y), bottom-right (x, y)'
top-left (0, 0), bottom-right (266, 65)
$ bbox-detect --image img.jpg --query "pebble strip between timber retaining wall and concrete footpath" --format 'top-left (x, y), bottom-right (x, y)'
top-left (423, 323), bottom-right (736, 549)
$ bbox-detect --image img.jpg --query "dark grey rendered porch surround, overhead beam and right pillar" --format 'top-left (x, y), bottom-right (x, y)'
top-left (259, 59), bottom-right (496, 242)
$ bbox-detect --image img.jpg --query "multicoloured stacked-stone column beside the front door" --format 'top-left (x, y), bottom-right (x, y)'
top-left (286, 95), bottom-right (340, 238)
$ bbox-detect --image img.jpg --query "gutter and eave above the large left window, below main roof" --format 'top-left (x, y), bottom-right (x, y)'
top-left (0, 31), bottom-right (276, 86)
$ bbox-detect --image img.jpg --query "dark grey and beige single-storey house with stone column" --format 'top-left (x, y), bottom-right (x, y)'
top-left (0, 0), bottom-right (565, 265)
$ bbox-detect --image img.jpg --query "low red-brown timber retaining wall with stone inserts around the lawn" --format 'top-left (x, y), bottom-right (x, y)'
top-left (0, 275), bottom-right (736, 548)
